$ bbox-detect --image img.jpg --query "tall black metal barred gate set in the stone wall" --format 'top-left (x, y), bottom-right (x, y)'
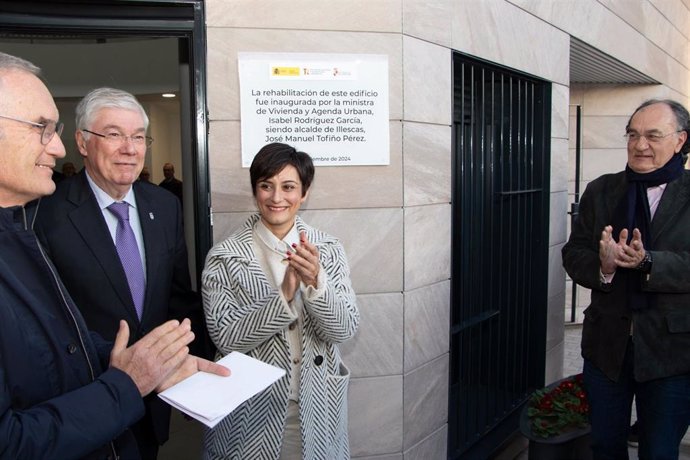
top-left (448, 53), bottom-right (551, 459)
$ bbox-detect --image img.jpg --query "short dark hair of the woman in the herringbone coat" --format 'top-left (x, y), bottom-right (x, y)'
top-left (249, 142), bottom-right (314, 196)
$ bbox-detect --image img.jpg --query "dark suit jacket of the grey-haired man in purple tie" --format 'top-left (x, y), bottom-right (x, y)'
top-left (34, 170), bottom-right (211, 446)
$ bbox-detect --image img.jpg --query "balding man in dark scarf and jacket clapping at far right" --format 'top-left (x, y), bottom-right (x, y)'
top-left (562, 100), bottom-right (690, 459)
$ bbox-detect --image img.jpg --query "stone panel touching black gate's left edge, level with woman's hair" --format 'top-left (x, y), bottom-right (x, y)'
top-left (403, 122), bottom-right (452, 206)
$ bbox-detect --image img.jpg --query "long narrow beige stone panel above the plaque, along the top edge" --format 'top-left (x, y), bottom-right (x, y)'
top-left (205, 0), bottom-right (402, 33)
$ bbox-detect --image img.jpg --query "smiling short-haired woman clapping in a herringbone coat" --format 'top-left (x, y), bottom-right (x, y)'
top-left (202, 143), bottom-right (359, 460)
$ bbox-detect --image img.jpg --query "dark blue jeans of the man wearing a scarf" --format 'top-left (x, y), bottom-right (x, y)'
top-left (584, 340), bottom-right (690, 460)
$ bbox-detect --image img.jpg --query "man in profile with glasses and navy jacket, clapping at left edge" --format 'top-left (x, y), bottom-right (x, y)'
top-left (0, 53), bottom-right (229, 460)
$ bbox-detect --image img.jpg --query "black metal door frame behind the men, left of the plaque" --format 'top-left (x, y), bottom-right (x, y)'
top-left (0, 0), bottom-right (213, 282)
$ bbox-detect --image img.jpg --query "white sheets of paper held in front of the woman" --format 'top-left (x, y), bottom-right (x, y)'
top-left (158, 351), bottom-right (285, 428)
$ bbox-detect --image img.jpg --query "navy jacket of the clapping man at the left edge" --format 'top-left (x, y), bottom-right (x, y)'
top-left (0, 207), bottom-right (144, 460)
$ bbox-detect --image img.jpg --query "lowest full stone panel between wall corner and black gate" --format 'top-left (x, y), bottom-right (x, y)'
top-left (403, 354), bottom-right (449, 450)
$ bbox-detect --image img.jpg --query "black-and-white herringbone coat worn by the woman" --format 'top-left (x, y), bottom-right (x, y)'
top-left (202, 214), bottom-right (359, 460)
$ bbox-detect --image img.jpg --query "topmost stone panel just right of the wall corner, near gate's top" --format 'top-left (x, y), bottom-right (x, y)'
top-left (403, 0), bottom-right (453, 48)
